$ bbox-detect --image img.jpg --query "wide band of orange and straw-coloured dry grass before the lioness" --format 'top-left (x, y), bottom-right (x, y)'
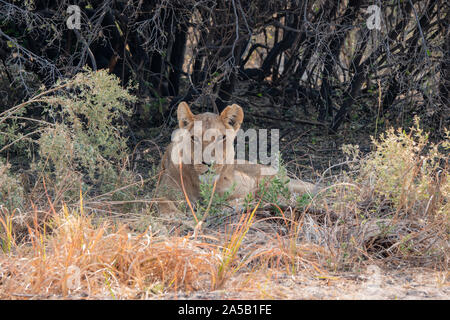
top-left (0, 184), bottom-right (445, 299)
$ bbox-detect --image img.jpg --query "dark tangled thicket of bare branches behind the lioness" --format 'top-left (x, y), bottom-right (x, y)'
top-left (0, 0), bottom-right (450, 138)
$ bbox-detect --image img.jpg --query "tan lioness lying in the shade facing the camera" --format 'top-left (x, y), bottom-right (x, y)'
top-left (158, 102), bottom-right (315, 213)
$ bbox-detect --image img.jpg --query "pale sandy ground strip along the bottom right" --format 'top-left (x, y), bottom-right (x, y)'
top-left (157, 265), bottom-right (450, 300)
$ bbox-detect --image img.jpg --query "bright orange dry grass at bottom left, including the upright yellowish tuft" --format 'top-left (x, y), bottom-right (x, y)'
top-left (0, 191), bottom-right (328, 299)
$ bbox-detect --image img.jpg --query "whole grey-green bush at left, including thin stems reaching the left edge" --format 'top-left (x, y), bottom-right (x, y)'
top-left (0, 69), bottom-right (140, 203)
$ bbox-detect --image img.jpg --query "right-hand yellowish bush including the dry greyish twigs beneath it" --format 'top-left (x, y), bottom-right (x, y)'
top-left (326, 118), bottom-right (450, 267)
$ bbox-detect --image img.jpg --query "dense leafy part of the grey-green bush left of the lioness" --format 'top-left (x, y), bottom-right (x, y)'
top-left (38, 70), bottom-right (135, 200)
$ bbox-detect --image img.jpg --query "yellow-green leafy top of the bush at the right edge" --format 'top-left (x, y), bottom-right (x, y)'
top-left (358, 118), bottom-right (450, 216)
